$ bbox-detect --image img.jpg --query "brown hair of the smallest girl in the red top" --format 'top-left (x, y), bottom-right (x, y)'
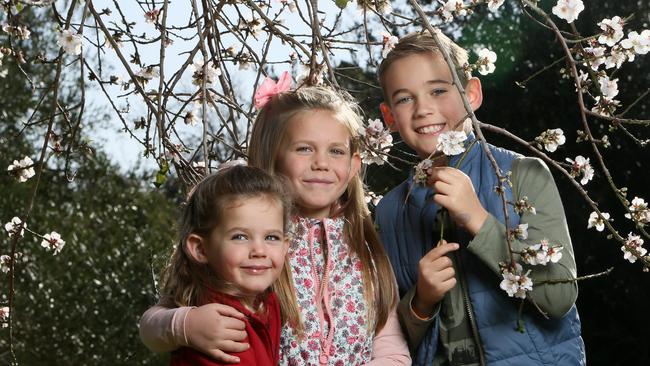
top-left (161, 166), bottom-right (292, 318)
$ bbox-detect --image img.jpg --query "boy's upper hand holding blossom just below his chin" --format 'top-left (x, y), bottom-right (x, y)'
top-left (429, 167), bottom-right (488, 235)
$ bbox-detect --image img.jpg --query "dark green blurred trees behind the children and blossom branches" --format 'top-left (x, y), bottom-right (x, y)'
top-left (0, 0), bottom-right (650, 365)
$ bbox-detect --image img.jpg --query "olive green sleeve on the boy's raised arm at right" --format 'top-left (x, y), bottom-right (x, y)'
top-left (468, 158), bottom-right (578, 318)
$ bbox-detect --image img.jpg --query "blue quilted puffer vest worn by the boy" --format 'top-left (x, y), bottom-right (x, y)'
top-left (376, 135), bottom-right (586, 366)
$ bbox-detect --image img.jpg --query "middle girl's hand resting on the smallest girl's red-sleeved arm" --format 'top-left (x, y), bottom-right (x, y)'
top-left (185, 304), bottom-right (250, 363)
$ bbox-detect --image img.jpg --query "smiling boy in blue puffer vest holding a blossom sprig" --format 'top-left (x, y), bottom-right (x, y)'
top-left (376, 32), bottom-right (586, 366)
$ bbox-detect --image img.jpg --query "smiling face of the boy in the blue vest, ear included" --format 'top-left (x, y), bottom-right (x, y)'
top-left (384, 53), bottom-right (483, 159)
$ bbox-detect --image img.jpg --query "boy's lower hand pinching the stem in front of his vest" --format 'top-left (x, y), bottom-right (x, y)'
top-left (412, 240), bottom-right (458, 318)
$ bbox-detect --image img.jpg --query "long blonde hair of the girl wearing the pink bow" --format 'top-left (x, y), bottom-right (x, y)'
top-left (248, 86), bottom-right (397, 332)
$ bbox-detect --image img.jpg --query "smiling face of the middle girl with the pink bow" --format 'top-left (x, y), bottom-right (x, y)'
top-left (276, 110), bottom-right (361, 218)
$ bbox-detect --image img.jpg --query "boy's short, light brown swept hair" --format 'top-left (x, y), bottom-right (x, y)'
top-left (378, 30), bottom-right (472, 101)
